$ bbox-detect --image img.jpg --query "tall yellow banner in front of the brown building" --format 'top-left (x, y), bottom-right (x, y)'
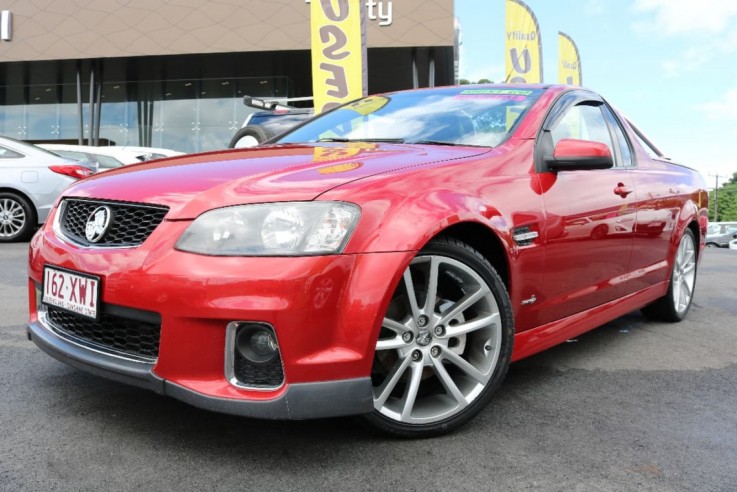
top-left (310, 0), bottom-right (366, 113)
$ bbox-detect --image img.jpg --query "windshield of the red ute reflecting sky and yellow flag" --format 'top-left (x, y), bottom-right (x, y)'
top-left (277, 86), bottom-right (543, 147)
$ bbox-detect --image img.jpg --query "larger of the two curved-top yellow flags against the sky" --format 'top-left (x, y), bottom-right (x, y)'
top-left (505, 0), bottom-right (543, 84)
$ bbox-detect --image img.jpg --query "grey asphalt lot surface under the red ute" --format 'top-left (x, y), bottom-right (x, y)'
top-left (0, 243), bottom-right (737, 492)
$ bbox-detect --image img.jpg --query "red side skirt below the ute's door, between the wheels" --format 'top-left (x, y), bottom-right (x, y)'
top-left (512, 281), bottom-right (668, 362)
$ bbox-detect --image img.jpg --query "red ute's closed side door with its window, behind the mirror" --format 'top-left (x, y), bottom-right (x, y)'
top-left (536, 93), bottom-right (636, 323)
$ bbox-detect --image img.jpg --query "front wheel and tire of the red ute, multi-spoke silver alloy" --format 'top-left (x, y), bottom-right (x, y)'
top-left (361, 238), bottom-right (514, 437)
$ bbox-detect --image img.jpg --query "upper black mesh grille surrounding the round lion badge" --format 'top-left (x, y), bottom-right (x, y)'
top-left (60, 199), bottom-right (169, 247)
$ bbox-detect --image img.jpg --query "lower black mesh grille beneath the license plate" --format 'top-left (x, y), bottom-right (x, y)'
top-left (46, 306), bottom-right (161, 362)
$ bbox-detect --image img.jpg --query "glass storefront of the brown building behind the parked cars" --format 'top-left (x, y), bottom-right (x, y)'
top-left (0, 77), bottom-right (291, 153)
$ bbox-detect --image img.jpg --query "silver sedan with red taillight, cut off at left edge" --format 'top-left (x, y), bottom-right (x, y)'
top-left (0, 137), bottom-right (93, 243)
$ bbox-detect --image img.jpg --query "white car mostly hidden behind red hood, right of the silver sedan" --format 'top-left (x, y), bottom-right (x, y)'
top-left (39, 143), bottom-right (183, 171)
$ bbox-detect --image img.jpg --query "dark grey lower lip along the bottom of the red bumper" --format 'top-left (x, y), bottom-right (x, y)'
top-left (28, 322), bottom-right (373, 420)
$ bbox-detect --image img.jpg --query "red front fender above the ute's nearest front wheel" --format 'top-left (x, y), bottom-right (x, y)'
top-left (321, 160), bottom-right (546, 330)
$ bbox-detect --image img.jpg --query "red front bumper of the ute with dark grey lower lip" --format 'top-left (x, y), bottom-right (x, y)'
top-left (28, 215), bottom-right (413, 419)
